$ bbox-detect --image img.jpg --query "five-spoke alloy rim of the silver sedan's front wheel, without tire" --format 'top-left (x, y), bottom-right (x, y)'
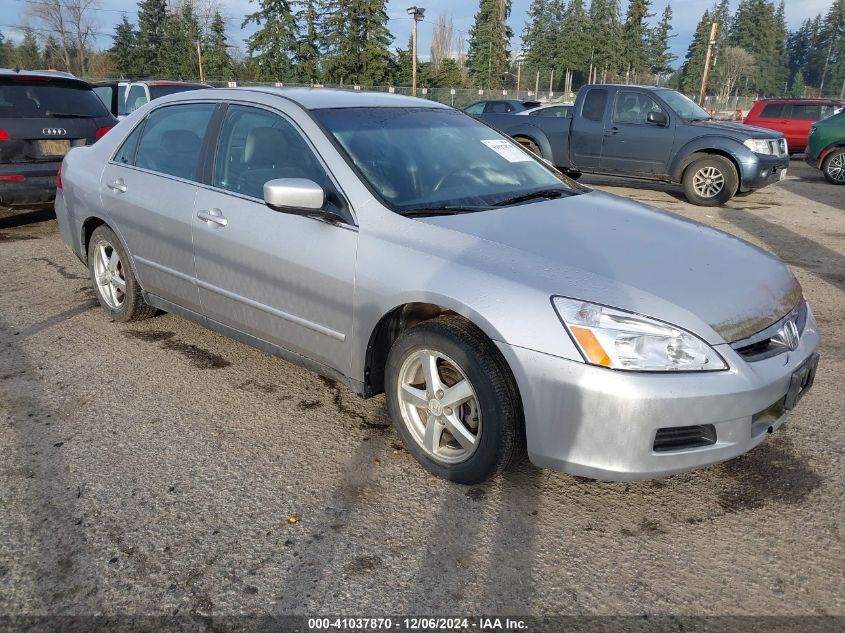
top-left (397, 349), bottom-right (481, 464)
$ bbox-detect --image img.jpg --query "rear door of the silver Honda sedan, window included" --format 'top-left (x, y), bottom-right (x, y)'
top-left (100, 102), bottom-right (215, 312)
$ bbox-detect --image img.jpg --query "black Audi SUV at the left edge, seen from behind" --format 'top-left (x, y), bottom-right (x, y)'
top-left (0, 69), bottom-right (117, 207)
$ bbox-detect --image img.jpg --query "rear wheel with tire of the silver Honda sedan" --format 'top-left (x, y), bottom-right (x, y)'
top-left (88, 225), bottom-right (156, 323)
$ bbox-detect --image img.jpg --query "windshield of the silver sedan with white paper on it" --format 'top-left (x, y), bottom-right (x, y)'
top-left (314, 108), bottom-right (579, 213)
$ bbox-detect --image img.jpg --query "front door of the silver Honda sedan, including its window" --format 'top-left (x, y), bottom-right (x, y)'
top-left (193, 105), bottom-right (358, 375)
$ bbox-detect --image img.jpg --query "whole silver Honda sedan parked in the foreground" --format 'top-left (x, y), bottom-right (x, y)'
top-left (56, 88), bottom-right (819, 484)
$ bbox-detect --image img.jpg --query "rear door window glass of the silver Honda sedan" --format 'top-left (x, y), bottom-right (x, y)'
top-left (135, 103), bottom-right (214, 180)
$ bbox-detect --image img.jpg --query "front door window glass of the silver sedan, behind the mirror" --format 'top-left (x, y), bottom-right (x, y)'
top-left (212, 106), bottom-right (326, 199)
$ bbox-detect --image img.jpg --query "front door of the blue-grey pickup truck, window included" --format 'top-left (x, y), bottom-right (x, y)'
top-left (601, 90), bottom-right (675, 176)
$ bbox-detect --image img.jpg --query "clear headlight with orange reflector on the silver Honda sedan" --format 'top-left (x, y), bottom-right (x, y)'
top-left (552, 297), bottom-right (728, 371)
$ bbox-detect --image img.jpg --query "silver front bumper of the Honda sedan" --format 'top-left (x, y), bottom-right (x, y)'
top-left (497, 312), bottom-right (819, 481)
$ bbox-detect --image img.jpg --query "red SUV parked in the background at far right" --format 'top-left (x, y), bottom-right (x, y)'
top-left (745, 99), bottom-right (845, 154)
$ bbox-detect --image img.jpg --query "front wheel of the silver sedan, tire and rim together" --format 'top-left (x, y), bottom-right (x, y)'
top-left (385, 316), bottom-right (525, 484)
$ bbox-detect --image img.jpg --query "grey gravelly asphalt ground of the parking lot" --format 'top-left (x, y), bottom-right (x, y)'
top-left (0, 161), bottom-right (845, 628)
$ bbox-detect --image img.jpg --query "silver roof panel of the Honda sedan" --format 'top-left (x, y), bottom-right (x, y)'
top-left (156, 86), bottom-right (449, 110)
